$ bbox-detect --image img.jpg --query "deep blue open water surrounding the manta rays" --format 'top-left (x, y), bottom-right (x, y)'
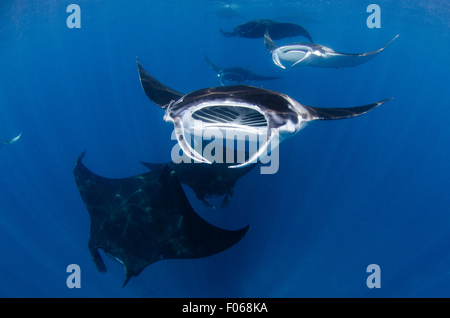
top-left (0, 0), bottom-right (450, 297)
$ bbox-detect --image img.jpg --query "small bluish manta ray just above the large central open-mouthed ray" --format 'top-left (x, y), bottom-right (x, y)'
top-left (205, 55), bottom-right (281, 86)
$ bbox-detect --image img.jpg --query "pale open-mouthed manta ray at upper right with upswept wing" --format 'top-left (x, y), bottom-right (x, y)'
top-left (264, 30), bottom-right (398, 68)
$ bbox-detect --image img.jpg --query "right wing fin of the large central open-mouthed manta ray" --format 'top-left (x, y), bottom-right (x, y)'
top-left (303, 97), bottom-right (392, 120)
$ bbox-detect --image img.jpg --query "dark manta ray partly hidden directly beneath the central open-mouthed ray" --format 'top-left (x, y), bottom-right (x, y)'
top-left (141, 161), bottom-right (256, 209)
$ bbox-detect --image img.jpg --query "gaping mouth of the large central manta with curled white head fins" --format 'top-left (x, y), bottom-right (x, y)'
top-left (178, 105), bottom-right (269, 168)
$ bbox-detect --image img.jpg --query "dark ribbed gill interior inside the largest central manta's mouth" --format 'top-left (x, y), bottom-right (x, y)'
top-left (192, 105), bottom-right (267, 127)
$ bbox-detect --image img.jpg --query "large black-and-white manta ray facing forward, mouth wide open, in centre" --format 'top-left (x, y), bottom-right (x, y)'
top-left (137, 61), bottom-right (391, 168)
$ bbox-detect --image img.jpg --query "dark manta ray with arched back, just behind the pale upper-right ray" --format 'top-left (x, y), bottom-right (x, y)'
top-left (220, 19), bottom-right (313, 43)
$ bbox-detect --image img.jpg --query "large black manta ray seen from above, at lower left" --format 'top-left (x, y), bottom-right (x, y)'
top-left (73, 152), bottom-right (248, 287)
